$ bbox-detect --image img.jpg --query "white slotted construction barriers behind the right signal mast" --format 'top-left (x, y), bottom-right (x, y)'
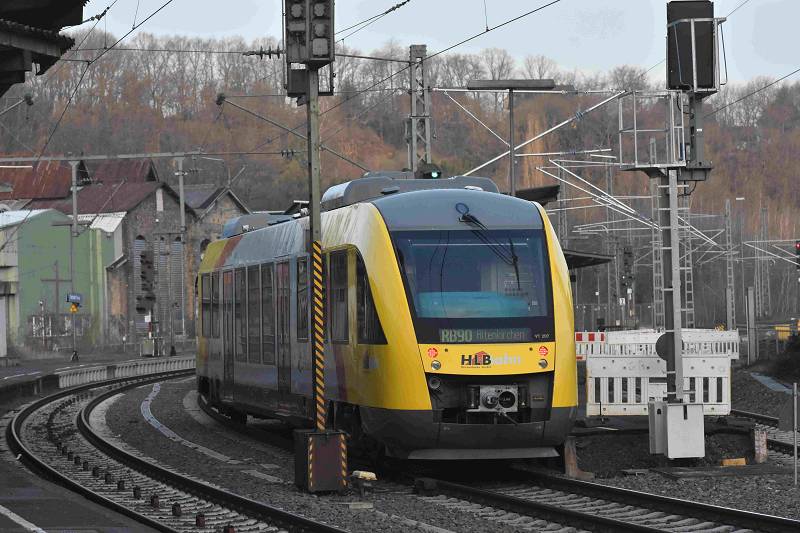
top-left (576, 329), bottom-right (739, 416)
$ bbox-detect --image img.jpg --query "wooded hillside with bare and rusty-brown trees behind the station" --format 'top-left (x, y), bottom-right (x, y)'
top-left (0, 33), bottom-right (800, 320)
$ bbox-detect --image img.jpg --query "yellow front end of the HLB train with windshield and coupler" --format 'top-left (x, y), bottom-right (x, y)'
top-left (361, 189), bottom-right (577, 460)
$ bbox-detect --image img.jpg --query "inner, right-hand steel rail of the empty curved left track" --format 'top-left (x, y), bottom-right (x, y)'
top-left (76, 376), bottom-right (345, 533)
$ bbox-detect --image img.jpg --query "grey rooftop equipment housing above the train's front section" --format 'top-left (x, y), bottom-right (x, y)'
top-left (321, 171), bottom-right (499, 211)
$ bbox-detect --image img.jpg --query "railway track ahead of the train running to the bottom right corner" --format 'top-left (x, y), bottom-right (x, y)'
top-left (416, 471), bottom-right (800, 533)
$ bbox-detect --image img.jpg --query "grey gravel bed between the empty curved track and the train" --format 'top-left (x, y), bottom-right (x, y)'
top-left (107, 380), bottom-right (532, 533)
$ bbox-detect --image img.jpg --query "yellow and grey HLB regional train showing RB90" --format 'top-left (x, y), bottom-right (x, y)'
top-left (197, 173), bottom-right (578, 460)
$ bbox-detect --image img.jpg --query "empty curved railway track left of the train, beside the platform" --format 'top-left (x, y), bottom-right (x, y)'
top-left (6, 370), bottom-right (343, 533)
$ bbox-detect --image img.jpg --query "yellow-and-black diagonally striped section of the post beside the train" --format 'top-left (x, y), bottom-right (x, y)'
top-left (311, 241), bottom-right (325, 431)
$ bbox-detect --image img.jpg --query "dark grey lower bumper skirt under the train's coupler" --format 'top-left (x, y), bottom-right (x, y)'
top-left (361, 407), bottom-right (576, 460)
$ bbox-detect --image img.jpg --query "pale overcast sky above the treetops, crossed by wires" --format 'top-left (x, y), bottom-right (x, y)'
top-left (84, 0), bottom-right (800, 81)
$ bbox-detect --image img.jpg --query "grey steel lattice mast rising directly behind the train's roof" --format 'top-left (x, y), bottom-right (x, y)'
top-left (406, 44), bottom-right (431, 172)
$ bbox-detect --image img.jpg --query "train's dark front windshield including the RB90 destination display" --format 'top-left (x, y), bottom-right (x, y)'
top-left (393, 228), bottom-right (553, 342)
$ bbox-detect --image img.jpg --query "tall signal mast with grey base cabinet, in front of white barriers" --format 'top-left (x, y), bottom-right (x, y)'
top-left (618, 0), bottom-right (725, 459)
